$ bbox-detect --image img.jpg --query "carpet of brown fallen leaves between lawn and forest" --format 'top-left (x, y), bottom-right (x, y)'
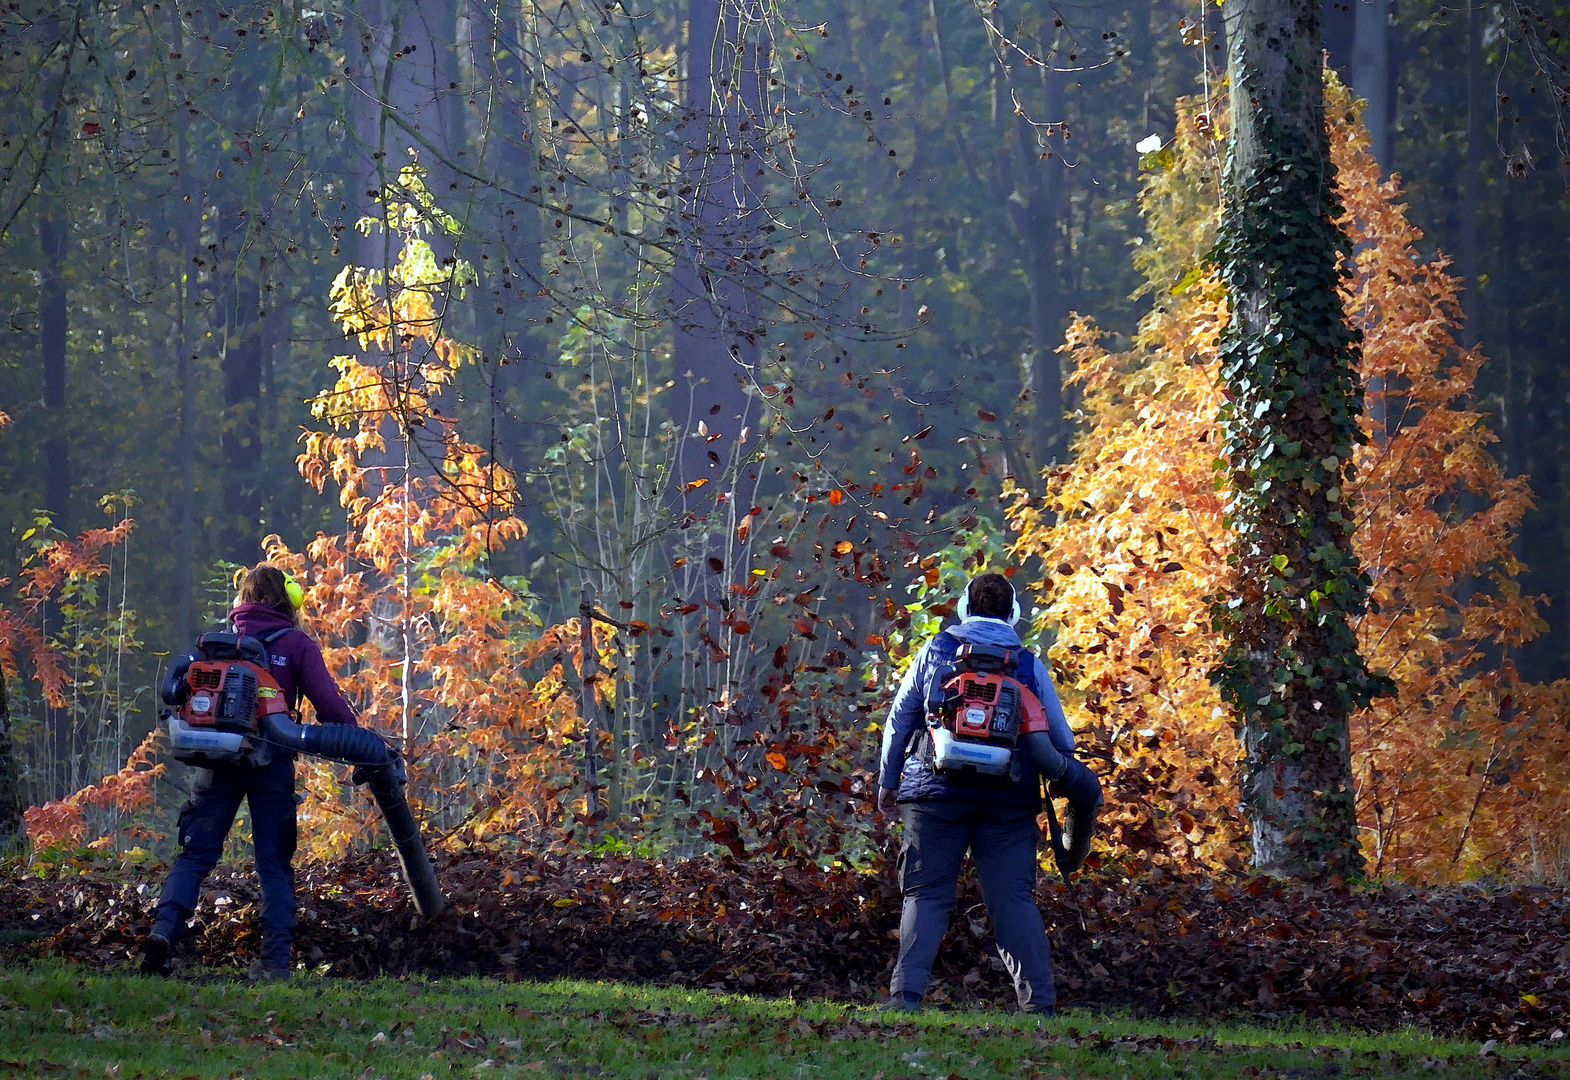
top-left (0, 851), bottom-right (1570, 1045)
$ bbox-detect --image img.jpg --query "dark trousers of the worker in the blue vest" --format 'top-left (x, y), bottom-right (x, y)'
top-left (889, 799), bottom-right (1057, 1009)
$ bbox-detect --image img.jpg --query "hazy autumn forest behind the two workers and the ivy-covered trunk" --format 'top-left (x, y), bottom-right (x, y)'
top-left (0, 0), bottom-right (1570, 879)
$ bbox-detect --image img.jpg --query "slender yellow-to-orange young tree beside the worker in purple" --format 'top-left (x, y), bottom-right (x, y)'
top-left (264, 166), bottom-right (602, 857)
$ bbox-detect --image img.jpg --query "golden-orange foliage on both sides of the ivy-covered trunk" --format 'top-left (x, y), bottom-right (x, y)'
top-left (1010, 85), bottom-right (1570, 881)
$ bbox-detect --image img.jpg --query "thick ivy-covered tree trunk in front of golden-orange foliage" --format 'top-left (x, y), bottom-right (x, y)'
top-left (1215, 0), bottom-right (1380, 878)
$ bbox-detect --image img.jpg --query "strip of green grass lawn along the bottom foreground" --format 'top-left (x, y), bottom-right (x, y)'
top-left (0, 964), bottom-right (1570, 1080)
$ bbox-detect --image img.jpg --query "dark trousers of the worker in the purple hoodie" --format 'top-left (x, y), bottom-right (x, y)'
top-left (152, 753), bottom-right (297, 969)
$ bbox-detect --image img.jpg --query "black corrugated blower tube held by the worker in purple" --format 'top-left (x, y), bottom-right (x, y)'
top-left (264, 713), bottom-right (447, 918)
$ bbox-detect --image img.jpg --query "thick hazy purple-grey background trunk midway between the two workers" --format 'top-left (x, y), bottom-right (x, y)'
top-left (669, 0), bottom-right (768, 750)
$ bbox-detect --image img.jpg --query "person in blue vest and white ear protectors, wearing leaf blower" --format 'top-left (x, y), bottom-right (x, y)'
top-left (878, 573), bottom-right (1101, 1016)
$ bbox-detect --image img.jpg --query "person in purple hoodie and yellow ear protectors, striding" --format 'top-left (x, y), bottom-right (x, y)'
top-left (141, 564), bottom-right (356, 978)
